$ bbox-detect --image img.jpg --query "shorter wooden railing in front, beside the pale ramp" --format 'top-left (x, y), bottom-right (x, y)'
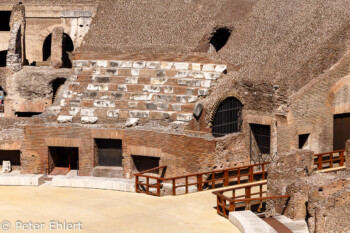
top-left (213, 181), bottom-right (290, 218)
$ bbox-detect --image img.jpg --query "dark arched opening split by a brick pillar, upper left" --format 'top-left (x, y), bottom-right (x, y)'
top-left (43, 33), bottom-right (74, 68)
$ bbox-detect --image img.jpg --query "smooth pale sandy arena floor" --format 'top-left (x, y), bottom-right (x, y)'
top-left (0, 182), bottom-right (250, 233)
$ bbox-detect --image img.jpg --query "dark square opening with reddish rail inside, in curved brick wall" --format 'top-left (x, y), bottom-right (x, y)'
top-left (48, 147), bottom-right (79, 175)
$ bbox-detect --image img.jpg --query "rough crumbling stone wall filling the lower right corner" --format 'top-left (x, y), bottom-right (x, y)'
top-left (267, 150), bottom-right (350, 232)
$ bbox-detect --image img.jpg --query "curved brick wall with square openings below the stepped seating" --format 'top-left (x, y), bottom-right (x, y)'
top-left (21, 126), bottom-right (216, 177)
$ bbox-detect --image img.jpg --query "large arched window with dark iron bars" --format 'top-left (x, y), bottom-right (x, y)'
top-left (212, 97), bottom-right (242, 137)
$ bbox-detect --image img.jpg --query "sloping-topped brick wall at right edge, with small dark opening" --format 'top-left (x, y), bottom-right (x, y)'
top-left (278, 51), bottom-right (350, 153)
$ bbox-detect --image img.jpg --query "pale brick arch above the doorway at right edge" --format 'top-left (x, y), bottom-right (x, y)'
top-left (325, 75), bottom-right (350, 114)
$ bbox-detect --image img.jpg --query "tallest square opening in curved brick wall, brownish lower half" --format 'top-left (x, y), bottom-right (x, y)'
top-left (95, 139), bottom-right (123, 167)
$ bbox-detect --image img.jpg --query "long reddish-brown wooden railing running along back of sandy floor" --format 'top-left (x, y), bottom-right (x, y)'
top-left (135, 163), bottom-right (269, 196)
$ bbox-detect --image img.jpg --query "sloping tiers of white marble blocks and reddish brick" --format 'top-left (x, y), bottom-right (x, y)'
top-left (53, 57), bottom-right (226, 126)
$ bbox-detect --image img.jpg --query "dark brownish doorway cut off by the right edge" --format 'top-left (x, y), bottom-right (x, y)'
top-left (333, 113), bottom-right (350, 150)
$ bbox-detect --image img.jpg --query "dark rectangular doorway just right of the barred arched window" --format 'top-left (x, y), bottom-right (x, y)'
top-left (250, 124), bottom-right (271, 154)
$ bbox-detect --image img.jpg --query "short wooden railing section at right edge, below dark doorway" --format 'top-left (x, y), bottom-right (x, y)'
top-left (314, 150), bottom-right (345, 170)
